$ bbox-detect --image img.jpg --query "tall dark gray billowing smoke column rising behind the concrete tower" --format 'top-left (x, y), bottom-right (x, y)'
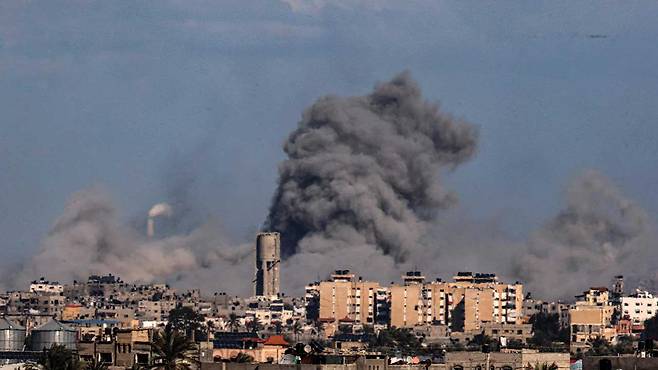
top-left (265, 72), bottom-right (478, 265)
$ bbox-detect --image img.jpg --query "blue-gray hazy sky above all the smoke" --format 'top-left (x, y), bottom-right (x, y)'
top-left (0, 0), bottom-right (658, 260)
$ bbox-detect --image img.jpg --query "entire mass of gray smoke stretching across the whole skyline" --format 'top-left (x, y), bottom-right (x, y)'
top-left (7, 73), bottom-right (658, 298)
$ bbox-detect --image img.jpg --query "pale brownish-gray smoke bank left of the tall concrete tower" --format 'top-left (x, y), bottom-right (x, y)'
top-left (14, 188), bottom-right (253, 294)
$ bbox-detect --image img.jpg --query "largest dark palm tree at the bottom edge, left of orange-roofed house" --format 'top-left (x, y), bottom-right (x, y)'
top-left (150, 325), bottom-right (199, 370)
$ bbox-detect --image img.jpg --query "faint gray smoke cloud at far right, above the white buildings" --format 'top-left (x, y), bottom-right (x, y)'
top-left (514, 171), bottom-right (655, 298)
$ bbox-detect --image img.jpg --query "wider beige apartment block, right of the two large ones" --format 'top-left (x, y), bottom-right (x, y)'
top-left (390, 271), bottom-right (523, 331)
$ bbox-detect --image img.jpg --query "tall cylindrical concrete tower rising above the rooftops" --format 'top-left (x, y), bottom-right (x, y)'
top-left (254, 233), bottom-right (281, 297)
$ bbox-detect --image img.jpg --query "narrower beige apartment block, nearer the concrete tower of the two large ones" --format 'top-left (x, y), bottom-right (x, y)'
top-left (319, 270), bottom-right (379, 324)
